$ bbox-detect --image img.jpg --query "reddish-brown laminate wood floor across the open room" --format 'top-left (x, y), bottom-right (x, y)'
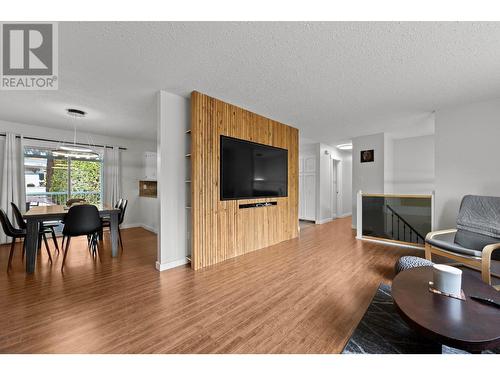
top-left (0, 217), bottom-right (418, 353)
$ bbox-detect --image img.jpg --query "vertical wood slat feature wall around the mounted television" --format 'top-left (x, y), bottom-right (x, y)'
top-left (191, 91), bottom-right (299, 269)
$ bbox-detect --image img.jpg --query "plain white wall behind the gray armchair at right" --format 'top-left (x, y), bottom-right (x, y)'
top-left (435, 100), bottom-right (500, 229)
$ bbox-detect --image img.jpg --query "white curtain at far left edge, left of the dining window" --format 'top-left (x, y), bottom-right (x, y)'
top-left (0, 133), bottom-right (26, 243)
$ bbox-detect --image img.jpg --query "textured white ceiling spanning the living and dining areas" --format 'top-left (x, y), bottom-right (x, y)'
top-left (0, 22), bottom-right (500, 144)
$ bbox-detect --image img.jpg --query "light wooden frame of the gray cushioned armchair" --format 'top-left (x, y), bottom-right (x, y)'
top-left (425, 229), bottom-right (500, 290)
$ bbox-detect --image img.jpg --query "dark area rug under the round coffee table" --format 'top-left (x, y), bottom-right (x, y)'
top-left (342, 284), bottom-right (500, 354)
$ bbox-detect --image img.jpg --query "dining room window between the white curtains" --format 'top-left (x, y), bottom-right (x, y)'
top-left (24, 146), bottom-right (102, 206)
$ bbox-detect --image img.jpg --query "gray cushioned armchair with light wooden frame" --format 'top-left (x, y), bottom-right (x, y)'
top-left (425, 195), bottom-right (500, 290)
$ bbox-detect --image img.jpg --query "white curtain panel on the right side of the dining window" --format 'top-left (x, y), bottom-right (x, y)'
top-left (103, 147), bottom-right (122, 206)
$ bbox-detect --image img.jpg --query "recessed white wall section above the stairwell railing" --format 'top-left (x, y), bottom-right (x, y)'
top-left (384, 135), bottom-right (434, 194)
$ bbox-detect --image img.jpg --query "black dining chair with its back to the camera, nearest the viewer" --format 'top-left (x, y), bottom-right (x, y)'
top-left (61, 204), bottom-right (102, 270)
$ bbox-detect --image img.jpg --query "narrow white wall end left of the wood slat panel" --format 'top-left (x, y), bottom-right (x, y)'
top-left (156, 91), bottom-right (190, 271)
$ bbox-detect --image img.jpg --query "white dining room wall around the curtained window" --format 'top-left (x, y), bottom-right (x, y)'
top-left (0, 120), bottom-right (159, 230)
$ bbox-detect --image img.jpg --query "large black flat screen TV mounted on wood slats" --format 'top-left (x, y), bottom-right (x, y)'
top-left (220, 135), bottom-right (288, 200)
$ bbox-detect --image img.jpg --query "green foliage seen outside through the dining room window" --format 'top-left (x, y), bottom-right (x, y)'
top-left (47, 159), bottom-right (101, 204)
